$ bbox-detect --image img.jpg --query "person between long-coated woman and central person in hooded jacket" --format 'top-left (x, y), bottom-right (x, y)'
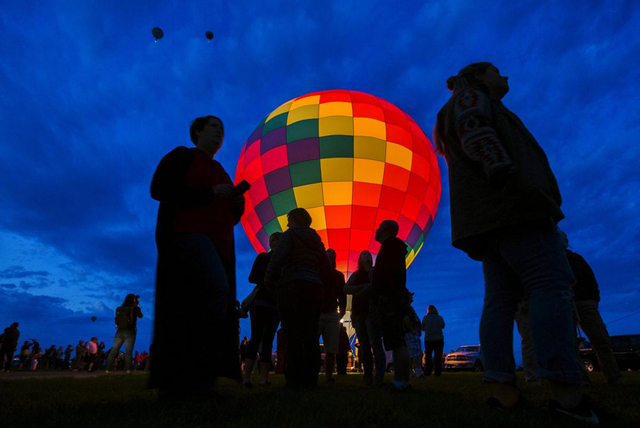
top-left (244, 232), bottom-right (281, 386)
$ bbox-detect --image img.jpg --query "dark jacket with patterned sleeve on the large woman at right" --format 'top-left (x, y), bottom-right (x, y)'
top-left (436, 88), bottom-right (564, 260)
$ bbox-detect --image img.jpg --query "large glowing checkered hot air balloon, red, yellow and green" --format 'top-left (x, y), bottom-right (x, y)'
top-left (236, 90), bottom-right (441, 275)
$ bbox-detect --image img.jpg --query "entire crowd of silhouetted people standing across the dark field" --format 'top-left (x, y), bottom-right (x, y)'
top-left (2, 62), bottom-right (622, 423)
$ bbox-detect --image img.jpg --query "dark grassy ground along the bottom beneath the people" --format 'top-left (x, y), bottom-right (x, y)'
top-left (0, 372), bottom-right (640, 428)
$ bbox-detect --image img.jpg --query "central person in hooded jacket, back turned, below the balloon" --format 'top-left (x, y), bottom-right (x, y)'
top-left (264, 208), bottom-right (331, 388)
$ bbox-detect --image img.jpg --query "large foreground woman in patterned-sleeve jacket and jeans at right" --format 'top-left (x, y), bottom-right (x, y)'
top-left (434, 62), bottom-right (597, 420)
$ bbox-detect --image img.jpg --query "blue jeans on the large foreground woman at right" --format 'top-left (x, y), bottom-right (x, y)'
top-left (480, 220), bottom-right (581, 385)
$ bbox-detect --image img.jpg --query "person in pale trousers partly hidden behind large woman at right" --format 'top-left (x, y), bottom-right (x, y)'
top-left (560, 231), bottom-right (622, 385)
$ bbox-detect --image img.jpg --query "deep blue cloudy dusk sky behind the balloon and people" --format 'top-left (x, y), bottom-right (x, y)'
top-left (0, 0), bottom-right (640, 362)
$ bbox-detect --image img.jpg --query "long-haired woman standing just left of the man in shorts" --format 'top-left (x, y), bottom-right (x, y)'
top-left (344, 250), bottom-right (387, 385)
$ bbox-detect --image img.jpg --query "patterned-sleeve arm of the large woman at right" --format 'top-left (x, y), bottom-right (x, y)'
top-left (454, 88), bottom-right (517, 185)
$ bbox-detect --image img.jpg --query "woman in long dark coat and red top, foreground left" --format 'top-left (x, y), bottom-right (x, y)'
top-left (150, 116), bottom-right (244, 399)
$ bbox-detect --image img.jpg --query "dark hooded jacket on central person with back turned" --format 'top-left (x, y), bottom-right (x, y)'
top-left (264, 227), bottom-right (333, 290)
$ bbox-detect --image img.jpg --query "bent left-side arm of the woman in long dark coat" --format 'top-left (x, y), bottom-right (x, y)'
top-left (151, 147), bottom-right (215, 207)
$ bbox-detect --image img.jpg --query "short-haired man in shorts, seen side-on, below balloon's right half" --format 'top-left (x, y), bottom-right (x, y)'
top-left (371, 220), bottom-right (411, 390)
